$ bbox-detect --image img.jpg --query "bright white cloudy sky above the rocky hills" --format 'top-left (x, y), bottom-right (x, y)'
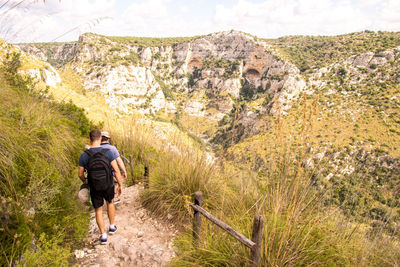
top-left (0, 0), bottom-right (400, 43)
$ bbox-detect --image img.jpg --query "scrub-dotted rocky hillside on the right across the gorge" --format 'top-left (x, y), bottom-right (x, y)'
top-left (224, 32), bottom-right (400, 244)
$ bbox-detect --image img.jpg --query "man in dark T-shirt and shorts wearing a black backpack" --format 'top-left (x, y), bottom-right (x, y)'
top-left (78, 130), bottom-right (122, 244)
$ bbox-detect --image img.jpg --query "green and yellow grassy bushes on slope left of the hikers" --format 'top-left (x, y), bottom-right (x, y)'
top-left (0, 53), bottom-right (94, 266)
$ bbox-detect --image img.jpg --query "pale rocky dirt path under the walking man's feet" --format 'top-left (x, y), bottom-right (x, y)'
top-left (75, 185), bottom-right (177, 267)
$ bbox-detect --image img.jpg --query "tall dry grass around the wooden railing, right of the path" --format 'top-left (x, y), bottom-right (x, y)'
top-left (107, 109), bottom-right (400, 266)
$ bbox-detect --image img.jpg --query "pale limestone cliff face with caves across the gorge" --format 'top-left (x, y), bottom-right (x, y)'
top-left (21, 31), bottom-right (305, 147)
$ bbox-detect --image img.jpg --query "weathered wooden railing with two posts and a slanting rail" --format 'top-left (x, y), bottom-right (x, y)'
top-left (189, 191), bottom-right (264, 267)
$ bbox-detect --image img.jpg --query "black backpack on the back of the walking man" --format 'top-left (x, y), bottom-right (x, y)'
top-left (85, 148), bottom-right (113, 191)
